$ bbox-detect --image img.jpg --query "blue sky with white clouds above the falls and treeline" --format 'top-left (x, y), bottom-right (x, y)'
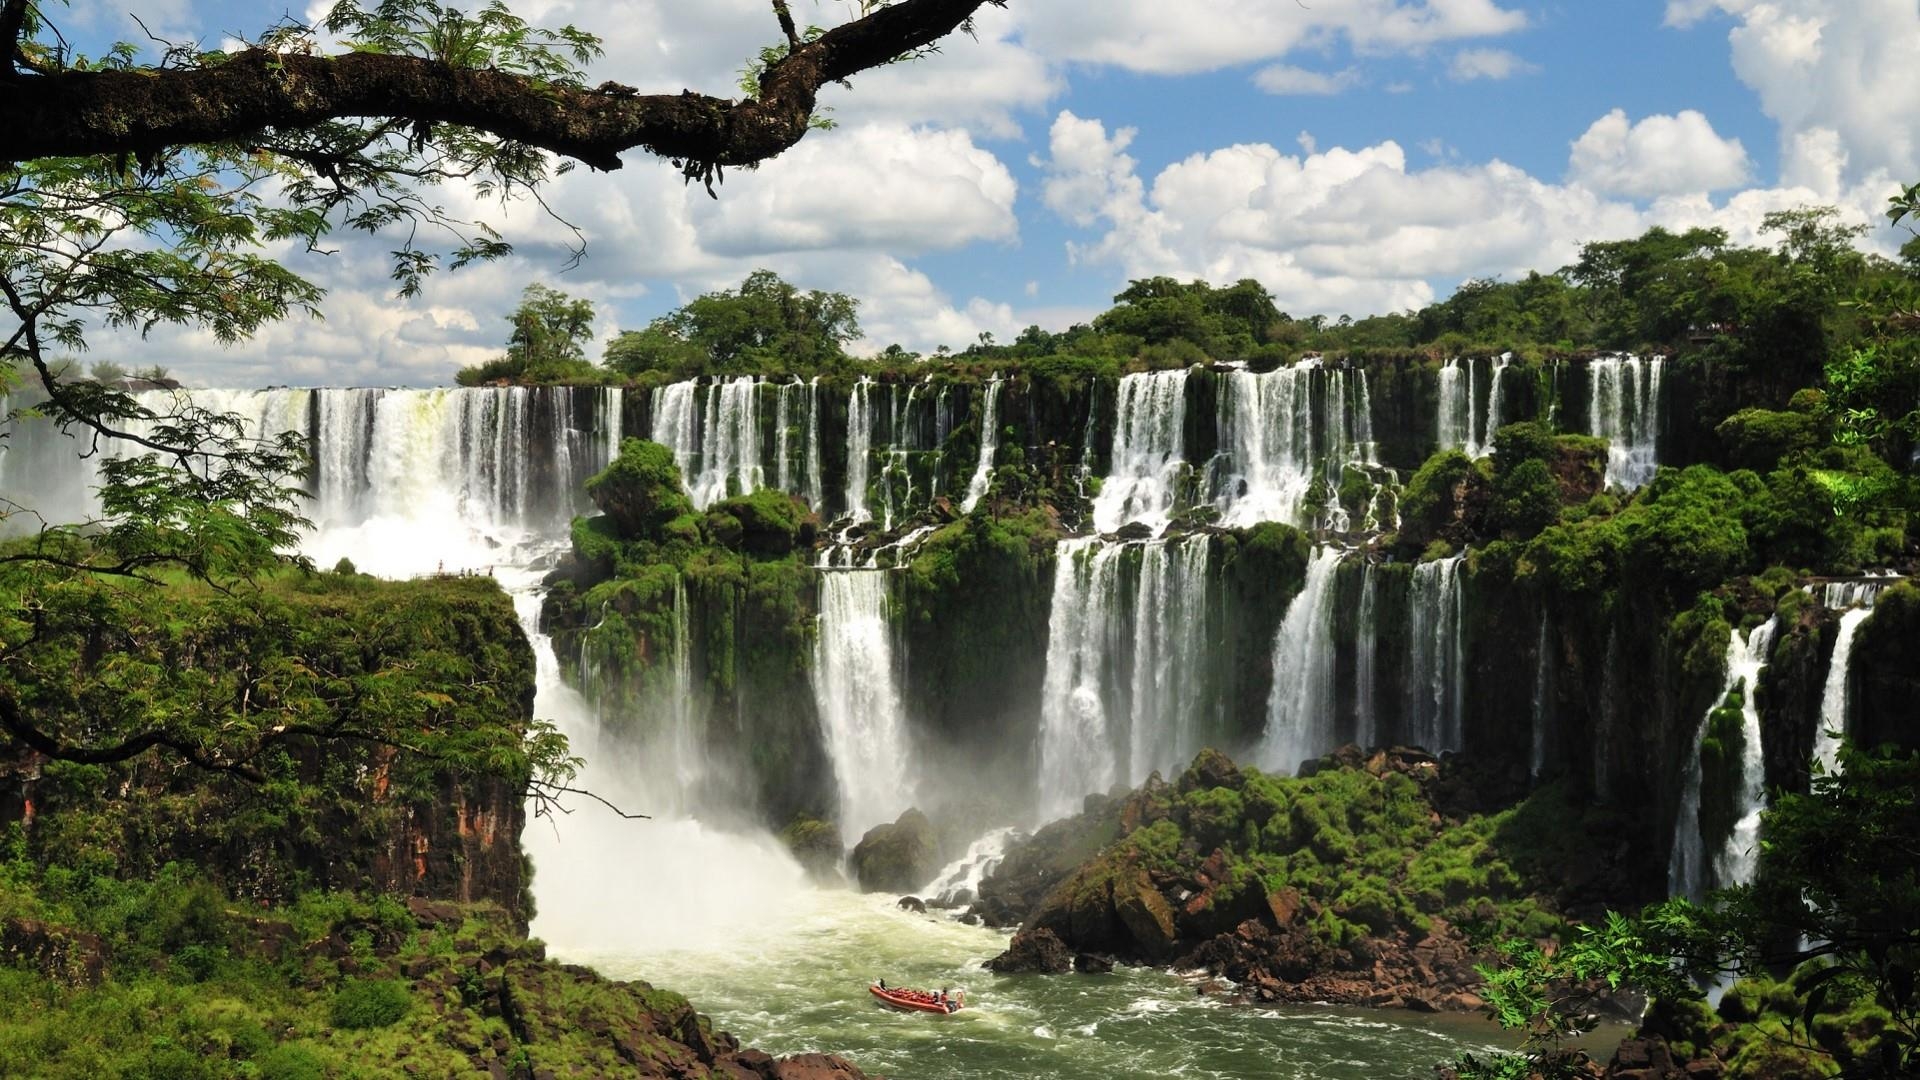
top-left (41, 0), bottom-right (1920, 386)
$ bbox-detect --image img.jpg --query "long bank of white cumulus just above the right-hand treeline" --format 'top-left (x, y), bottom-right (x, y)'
top-left (1044, 113), bottom-right (1870, 315)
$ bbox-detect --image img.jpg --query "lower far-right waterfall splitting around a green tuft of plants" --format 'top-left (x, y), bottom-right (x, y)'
top-left (1667, 619), bottom-right (1778, 899)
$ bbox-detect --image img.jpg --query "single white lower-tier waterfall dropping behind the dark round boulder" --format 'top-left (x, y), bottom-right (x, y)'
top-left (814, 548), bottom-right (912, 838)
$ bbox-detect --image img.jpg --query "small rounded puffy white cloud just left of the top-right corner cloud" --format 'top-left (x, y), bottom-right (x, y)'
top-left (1567, 110), bottom-right (1749, 196)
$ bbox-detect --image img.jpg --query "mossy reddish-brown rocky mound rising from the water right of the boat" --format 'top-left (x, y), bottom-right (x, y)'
top-left (975, 748), bottom-right (1589, 1011)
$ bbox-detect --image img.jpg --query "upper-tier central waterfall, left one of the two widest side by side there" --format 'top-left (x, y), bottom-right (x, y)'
top-left (1092, 371), bottom-right (1187, 532)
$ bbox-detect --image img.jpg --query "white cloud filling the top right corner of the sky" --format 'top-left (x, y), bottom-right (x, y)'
top-left (1667, 0), bottom-right (1920, 188)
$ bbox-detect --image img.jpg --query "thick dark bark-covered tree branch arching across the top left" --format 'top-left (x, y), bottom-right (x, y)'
top-left (0, 0), bottom-right (1004, 177)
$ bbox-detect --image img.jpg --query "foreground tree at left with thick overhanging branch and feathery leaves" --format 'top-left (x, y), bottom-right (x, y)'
top-left (0, 0), bottom-right (998, 796)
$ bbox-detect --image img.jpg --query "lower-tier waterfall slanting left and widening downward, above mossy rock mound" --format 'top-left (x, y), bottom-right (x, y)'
top-left (1258, 548), bottom-right (1346, 774)
